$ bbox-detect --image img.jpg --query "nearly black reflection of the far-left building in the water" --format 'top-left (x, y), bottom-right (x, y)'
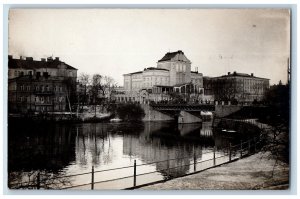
top-left (8, 123), bottom-right (75, 172)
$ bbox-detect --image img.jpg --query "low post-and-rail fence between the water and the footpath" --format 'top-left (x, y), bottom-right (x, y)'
top-left (9, 136), bottom-right (263, 190)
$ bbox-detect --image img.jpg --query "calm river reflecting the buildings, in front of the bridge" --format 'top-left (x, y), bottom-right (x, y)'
top-left (8, 119), bottom-right (260, 189)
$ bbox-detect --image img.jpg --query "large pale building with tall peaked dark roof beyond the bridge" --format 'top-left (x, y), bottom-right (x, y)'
top-left (115, 50), bottom-right (203, 103)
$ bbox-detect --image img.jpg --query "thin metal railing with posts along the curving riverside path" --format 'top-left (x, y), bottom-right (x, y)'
top-left (9, 136), bottom-right (262, 190)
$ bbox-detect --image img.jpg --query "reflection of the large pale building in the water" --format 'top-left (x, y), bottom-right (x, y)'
top-left (123, 123), bottom-right (193, 177)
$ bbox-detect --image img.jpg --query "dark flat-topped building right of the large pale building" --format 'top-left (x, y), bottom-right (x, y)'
top-left (203, 72), bottom-right (269, 103)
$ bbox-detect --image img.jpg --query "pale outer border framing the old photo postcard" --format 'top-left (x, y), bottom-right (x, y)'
top-left (0, 0), bottom-right (300, 199)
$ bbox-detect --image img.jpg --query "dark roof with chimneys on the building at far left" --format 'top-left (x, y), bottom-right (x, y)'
top-left (8, 58), bottom-right (77, 70)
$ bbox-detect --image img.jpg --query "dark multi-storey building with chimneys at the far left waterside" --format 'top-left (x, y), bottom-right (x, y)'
top-left (8, 56), bottom-right (77, 113)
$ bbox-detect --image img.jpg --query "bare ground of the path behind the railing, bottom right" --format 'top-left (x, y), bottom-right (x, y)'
top-left (140, 152), bottom-right (289, 190)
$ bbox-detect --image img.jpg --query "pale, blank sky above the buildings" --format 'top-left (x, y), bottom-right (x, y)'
top-left (9, 9), bottom-right (290, 86)
